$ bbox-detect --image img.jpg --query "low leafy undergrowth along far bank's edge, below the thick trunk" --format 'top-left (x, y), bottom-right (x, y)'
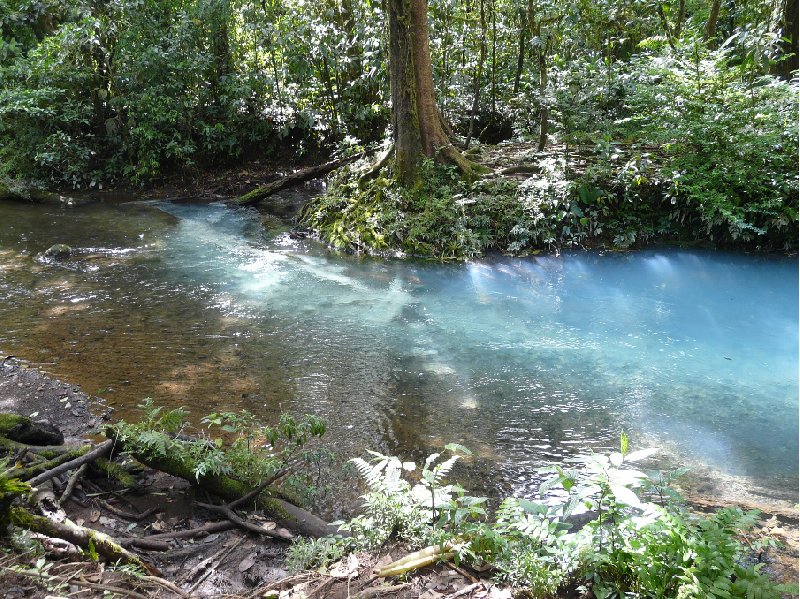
top-left (300, 149), bottom-right (797, 260)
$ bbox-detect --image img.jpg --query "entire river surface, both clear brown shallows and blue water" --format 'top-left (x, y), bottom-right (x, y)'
top-left (0, 202), bottom-right (798, 512)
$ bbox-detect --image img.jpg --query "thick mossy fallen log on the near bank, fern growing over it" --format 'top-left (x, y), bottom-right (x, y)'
top-left (106, 427), bottom-right (338, 538)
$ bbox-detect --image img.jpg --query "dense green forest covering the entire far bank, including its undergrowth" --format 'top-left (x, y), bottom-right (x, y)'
top-left (0, 0), bottom-right (798, 259)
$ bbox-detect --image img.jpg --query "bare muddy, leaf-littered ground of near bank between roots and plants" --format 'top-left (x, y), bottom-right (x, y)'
top-left (0, 357), bottom-right (798, 599)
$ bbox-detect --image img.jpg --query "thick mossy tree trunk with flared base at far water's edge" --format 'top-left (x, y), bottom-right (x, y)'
top-left (388, 0), bottom-right (475, 186)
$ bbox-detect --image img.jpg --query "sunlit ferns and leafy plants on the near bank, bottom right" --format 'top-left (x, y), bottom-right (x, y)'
top-left (304, 433), bottom-right (797, 599)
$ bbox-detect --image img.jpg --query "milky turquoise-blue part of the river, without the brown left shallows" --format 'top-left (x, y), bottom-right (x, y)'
top-left (153, 205), bottom-right (798, 504)
